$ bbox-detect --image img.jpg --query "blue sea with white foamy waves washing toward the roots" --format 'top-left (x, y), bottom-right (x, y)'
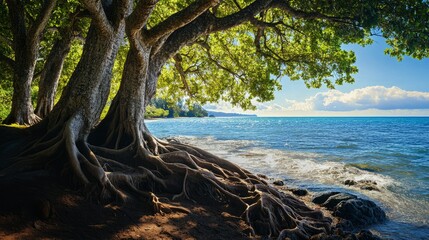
top-left (147, 117), bottom-right (429, 240)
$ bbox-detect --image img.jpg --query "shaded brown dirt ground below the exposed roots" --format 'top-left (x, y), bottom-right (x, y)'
top-left (0, 175), bottom-right (254, 240)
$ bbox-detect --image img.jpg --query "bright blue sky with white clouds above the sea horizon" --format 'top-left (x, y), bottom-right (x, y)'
top-left (205, 38), bottom-right (429, 116)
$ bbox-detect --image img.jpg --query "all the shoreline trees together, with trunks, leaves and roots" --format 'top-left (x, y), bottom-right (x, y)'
top-left (0, 0), bottom-right (429, 239)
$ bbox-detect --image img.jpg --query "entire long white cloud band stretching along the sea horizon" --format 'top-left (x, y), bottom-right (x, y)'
top-left (204, 86), bottom-right (429, 116)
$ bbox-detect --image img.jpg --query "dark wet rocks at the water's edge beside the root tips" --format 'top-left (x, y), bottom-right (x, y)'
top-left (270, 175), bottom-right (387, 240)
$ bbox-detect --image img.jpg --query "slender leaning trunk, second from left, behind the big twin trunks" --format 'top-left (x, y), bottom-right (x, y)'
top-left (35, 32), bottom-right (73, 118)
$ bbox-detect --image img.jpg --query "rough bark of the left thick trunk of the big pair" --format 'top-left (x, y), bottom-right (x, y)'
top-left (47, 22), bottom-right (124, 136)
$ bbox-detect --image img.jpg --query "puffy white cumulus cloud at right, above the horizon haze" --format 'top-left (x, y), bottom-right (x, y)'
top-left (286, 86), bottom-right (429, 111)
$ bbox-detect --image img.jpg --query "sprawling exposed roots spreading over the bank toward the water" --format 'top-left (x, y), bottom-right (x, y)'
top-left (0, 123), bottom-right (331, 239)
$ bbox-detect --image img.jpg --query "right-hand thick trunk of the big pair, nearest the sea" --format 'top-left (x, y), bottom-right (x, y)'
top-left (91, 45), bottom-right (150, 149)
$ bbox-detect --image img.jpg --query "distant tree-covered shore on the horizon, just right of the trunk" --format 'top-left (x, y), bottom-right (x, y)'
top-left (145, 98), bottom-right (208, 118)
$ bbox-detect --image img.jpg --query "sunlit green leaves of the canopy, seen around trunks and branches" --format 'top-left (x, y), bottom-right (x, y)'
top-left (0, 0), bottom-right (429, 118)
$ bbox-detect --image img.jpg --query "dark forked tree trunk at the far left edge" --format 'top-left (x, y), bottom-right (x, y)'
top-left (3, 0), bottom-right (56, 125)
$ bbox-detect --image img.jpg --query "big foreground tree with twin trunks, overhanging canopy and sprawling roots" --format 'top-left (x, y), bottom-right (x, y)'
top-left (0, 0), bottom-right (429, 239)
